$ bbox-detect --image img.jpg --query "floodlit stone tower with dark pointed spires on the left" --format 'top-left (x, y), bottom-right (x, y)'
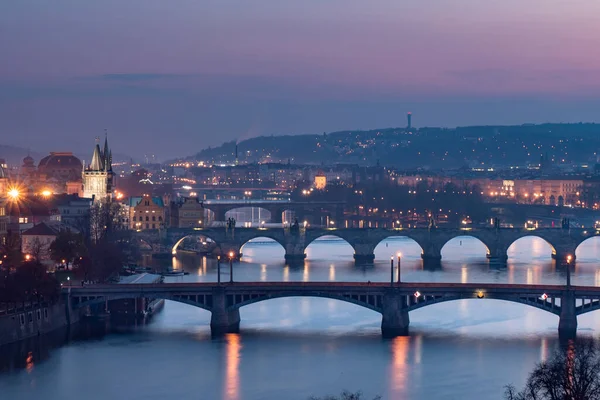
top-left (82, 136), bottom-right (113, 200)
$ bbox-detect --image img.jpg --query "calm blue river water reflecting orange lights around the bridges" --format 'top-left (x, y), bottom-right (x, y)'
top-left (0, 237), bottom-right (600, 400)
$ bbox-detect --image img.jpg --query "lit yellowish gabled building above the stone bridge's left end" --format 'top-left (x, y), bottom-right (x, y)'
top-left (129, 194), bottom-right (168, 231)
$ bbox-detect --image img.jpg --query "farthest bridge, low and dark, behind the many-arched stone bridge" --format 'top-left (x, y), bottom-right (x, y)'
top-left (202, 200), bottom-right (346, 223)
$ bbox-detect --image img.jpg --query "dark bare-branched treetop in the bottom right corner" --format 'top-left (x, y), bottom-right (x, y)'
top-left (505, 341), bottom-right (600, 400)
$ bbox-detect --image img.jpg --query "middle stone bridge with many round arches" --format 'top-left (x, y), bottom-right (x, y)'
top-left (135, 227), bottom-right (600, 263)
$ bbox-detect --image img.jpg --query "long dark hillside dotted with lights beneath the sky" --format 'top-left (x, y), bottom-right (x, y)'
top-left (186, 123), bottom-right (600, 168)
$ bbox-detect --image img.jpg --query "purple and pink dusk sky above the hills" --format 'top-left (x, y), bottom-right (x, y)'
top-left (0, 0), bottom-right (600, 159)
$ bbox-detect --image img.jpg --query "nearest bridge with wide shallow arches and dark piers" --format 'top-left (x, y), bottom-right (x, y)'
top-left (63, 277), bottom-right (600, 337)
